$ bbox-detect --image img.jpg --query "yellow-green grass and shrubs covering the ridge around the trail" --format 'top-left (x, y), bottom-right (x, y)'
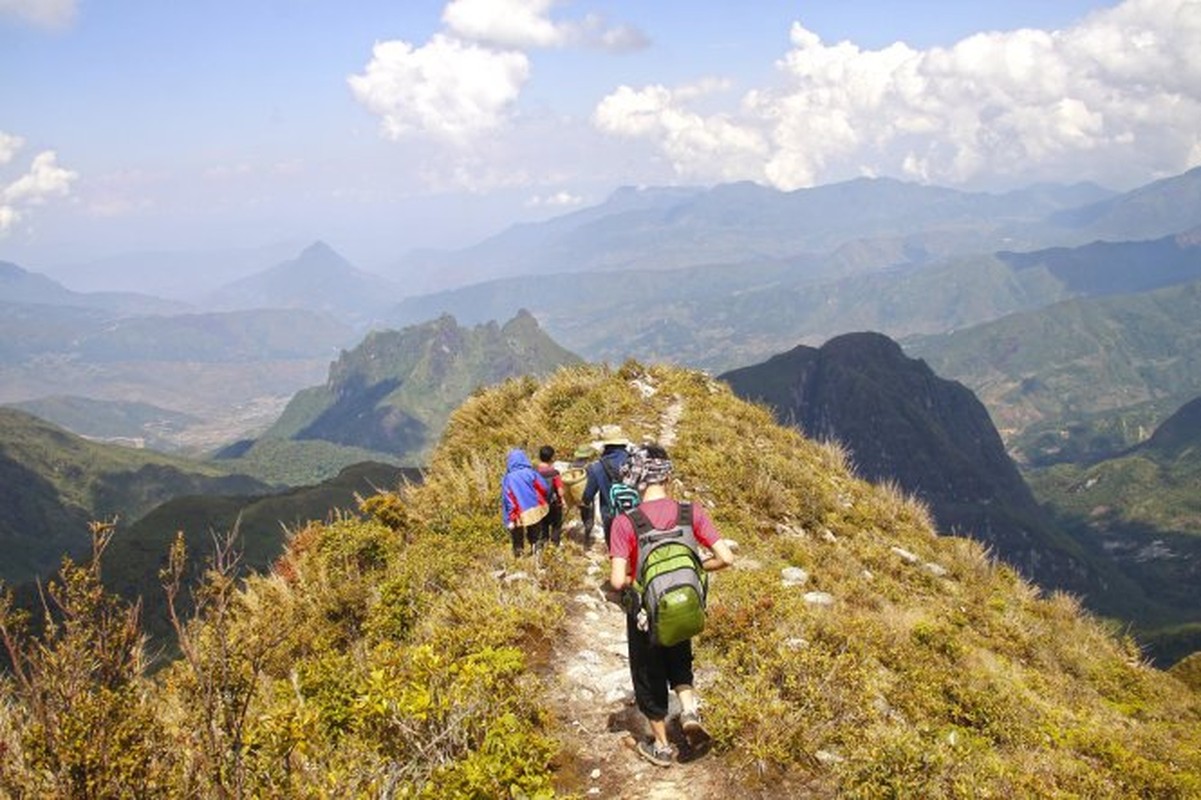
top-left (0, 362), bottom-right (1201, 798)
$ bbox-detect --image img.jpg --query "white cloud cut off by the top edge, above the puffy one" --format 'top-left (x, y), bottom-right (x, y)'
top-left (442, 0), bottom-right (646, 50)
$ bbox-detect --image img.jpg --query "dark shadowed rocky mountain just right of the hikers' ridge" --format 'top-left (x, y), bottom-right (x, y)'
top-left (721, 333), bottom-right (1106, 595)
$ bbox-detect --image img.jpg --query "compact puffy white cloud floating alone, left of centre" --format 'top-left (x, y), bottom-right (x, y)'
top-left (348, 34), bottom-right (530, 144)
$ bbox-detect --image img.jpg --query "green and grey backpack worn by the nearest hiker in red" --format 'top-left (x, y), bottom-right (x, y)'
top-left (626, 503), bottom-right (709, 647)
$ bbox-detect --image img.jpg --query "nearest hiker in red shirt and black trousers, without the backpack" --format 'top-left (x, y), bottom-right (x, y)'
top-left (609, 444), bottom-right (734, 766)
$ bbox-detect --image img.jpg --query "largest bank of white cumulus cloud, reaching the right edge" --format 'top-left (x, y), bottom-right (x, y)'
top-left (593, 0), bottom-right (1201, 189)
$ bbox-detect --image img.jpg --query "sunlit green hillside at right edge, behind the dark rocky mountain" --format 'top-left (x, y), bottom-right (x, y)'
top-left (906, 276), bottom-right (1201, 465)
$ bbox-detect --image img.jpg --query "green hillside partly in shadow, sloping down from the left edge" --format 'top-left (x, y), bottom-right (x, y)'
top-left (0, 408), bottom-right (268, 581)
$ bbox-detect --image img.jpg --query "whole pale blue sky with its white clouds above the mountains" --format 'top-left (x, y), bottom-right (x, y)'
top-left (0, 0), bottom-right (1201, 274)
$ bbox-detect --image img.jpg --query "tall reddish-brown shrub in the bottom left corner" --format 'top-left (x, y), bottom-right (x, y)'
top-left (0, 523), bottom-right (168, 798)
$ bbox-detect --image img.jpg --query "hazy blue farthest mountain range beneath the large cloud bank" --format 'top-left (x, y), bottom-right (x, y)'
top-left (388, 178), bottom-right (1110, 291)
